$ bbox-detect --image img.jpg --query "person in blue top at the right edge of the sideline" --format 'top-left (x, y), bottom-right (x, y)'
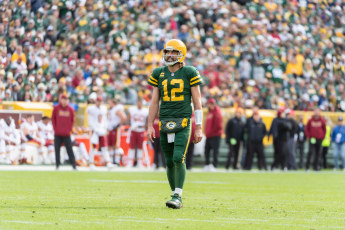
top-left (332, 116), bottom-right (345, 170)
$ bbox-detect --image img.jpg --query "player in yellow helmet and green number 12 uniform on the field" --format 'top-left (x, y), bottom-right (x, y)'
top-left (147, 39), bottom-right (202, 209)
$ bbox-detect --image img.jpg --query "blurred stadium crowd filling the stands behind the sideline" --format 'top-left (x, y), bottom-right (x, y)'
top-left (0, 0), bottom-right (345, 111)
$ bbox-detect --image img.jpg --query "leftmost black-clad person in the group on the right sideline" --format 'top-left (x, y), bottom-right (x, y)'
top-left (225, 108), bottom-right (245, 169)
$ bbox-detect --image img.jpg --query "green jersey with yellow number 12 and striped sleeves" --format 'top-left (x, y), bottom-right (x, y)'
top-left (148, 66), bottom-right (202, 119)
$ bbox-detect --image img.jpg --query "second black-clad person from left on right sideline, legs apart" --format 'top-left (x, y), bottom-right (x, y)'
top-left (244, 111), bottom-right (267, 170)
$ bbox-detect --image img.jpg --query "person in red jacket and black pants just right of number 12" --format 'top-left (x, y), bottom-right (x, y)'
top-left (204, 98), bottom-right (223, 171)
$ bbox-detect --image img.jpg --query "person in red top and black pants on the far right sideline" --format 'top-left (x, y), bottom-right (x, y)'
top-left (305, 108), bottom-right (326, 171)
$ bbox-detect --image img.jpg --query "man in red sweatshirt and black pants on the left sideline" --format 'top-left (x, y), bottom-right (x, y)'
top-left (52, 94), bottom-right (76, 170)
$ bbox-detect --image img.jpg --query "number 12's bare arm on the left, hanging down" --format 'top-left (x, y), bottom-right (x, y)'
top-left (147, 87), bottom-right (160, 142)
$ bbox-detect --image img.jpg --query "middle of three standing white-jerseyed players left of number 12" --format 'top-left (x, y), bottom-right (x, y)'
top-left (108, 98), bottom-right (127, 165)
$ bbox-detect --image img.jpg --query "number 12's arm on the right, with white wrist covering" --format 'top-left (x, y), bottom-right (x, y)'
top-left (191, 85), bottom-right (202, 144)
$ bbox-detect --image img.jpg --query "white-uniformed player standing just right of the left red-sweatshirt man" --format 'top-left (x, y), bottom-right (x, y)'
top-left (87, 97), bottom-right (114, 170)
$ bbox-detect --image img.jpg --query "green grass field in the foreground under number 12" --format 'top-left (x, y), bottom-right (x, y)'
top-left (0, 171), bottom-right (345, 229)
